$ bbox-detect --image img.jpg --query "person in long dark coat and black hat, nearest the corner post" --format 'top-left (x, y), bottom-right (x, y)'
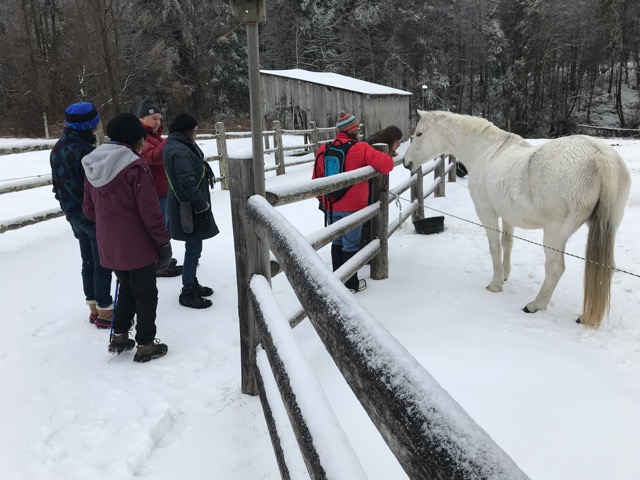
top-left (163, 113), bottom-right (219, 308)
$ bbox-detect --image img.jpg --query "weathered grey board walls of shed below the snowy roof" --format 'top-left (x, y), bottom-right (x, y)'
top-left (261, 74), bottom-right (410, 138)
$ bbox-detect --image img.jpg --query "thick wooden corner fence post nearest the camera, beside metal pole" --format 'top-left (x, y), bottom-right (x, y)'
top-left (228, 158), bottom-right (271, 395)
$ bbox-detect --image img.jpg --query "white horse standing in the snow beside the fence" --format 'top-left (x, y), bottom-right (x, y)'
top-left (404, 111), bottom-right (631, 327)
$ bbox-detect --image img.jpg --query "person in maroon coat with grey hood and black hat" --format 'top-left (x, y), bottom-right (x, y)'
top-left (82, 113), bottom-right (171, 362)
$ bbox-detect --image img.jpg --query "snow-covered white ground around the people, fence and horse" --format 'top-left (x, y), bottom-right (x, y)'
top-left (0, 135), bottom-right (640, 480)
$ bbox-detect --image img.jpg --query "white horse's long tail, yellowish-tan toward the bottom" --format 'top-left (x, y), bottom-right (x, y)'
top-left (580, 152), bottom-right (631, 328)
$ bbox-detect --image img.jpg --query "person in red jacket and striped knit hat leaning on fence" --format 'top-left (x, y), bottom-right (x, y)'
top-left (312, 111), bottom-right (394, 293)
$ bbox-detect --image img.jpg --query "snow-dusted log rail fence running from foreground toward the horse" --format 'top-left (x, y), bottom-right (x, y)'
top-left (229, 148), bottom-right (527, 480)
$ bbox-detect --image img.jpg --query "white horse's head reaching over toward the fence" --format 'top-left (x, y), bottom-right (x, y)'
top-left (403, 110), bottom-right (449, 170)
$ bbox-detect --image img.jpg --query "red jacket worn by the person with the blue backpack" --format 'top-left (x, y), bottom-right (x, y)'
top-left (311, 132), bottom-right (394, 212)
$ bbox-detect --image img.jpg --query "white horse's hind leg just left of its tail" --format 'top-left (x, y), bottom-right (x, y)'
top-left (522, 227), bottom-right (571, 313)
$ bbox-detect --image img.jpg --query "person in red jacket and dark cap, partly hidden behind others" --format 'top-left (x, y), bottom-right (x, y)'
top-left (138, 97), bottom-right (182, 277)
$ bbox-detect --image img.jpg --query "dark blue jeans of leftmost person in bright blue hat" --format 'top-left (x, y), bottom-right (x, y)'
top-left (69, 221), bottom-right (113, 308)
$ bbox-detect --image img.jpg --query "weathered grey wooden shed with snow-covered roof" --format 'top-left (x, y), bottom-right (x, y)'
top-left (260, 69), bottom-right (412, 138)
